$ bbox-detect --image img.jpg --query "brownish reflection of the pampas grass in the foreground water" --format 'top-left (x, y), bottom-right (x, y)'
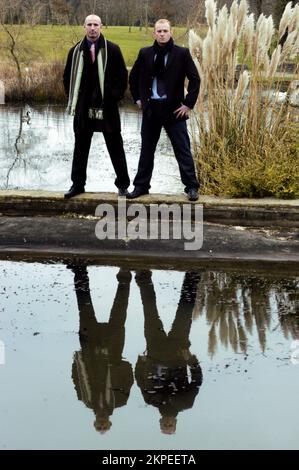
top-left (192, 271), bottom-right (299, 357)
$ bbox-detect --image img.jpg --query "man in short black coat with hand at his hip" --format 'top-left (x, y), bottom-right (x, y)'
top-left (128, 19), bottom-right (200, 201)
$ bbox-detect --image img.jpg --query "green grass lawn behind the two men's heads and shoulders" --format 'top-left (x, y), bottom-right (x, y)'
top-left (0, 25), bottom-right (187, 66)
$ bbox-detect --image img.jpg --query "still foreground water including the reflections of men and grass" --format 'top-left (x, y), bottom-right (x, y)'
top-left (0, 261), bottom-right (299, 449)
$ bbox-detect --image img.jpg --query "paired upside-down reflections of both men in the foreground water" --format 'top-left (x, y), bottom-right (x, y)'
top-left (71, 265), bottom-right (202, 434)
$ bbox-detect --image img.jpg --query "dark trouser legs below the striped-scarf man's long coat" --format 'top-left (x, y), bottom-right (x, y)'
top-left (71, 130), bottom-right (130, 188)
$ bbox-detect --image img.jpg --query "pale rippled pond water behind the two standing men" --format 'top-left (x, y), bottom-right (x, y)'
top-left (0, 106), bottom-right (183, 194)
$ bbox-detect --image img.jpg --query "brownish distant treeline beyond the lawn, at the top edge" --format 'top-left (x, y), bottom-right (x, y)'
top-left (0, 0), bottom-right (295, 27)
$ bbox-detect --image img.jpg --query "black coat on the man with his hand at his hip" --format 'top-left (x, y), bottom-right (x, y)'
top-left (129, 45), bottom-right (200, 111)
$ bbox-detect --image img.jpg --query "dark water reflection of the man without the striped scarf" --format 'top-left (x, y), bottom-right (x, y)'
top-left (135, 270), bottom-right (202, 434)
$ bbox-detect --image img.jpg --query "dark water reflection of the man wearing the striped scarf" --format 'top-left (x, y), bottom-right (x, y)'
top-left (69, 265), bottom-right (134, 433)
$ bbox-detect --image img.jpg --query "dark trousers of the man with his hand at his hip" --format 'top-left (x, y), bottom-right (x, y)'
top-left (134, 101), bottom-right (199, 191)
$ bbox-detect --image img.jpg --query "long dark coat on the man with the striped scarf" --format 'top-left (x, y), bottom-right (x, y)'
top-left (63, 35), bottom-right (128, 132)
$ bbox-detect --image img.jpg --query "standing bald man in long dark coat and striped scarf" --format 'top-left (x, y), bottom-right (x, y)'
top-left (63, 15), bottom-right (130, 199)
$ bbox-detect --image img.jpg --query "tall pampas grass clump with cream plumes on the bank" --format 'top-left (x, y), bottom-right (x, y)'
top-left (189, 0), bottom-right (299, 198)
